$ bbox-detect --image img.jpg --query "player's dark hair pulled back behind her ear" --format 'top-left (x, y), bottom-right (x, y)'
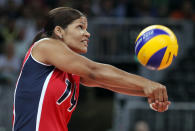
top-left (33, 7), bottom-right (85, 43)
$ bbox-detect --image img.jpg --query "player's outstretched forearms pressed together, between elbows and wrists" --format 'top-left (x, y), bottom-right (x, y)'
top-left (92, 64), bottom-right (155, 91)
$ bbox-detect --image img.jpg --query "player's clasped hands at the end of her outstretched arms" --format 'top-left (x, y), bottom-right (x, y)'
top-left (144, 82), bottom-right (171, 112)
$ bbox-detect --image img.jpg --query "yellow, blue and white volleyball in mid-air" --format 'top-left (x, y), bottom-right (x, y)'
top-left (135, 25), bottom-right (178, 70)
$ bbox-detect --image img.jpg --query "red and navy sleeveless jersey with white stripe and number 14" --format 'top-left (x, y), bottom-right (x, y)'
top-left (13, 43), bottom-right (80, 131)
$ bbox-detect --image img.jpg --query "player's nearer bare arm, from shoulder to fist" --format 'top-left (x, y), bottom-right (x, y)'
top-left (32, 39), bottom-right (171, 112)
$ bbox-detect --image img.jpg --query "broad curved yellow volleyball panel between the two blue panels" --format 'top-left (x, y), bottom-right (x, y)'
top-left (137, 35), bottom-right (168, 65)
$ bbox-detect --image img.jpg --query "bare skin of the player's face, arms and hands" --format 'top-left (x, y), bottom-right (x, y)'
top-left (32, 17), bottom-right (170, 112)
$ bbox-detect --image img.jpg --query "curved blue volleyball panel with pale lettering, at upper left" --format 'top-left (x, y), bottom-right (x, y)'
top-left (135, 29), bottom-right (169, 55)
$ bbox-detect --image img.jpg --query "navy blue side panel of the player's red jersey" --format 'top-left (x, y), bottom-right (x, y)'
top-left (14, 55), bottom-right (54, 131)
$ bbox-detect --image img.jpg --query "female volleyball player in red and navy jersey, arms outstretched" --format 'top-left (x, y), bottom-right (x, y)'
top-left (13, 7), bottom-right (170, 131)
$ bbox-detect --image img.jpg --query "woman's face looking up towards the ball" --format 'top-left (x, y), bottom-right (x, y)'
top-left (62, 17), bottom-right (90, 54)
